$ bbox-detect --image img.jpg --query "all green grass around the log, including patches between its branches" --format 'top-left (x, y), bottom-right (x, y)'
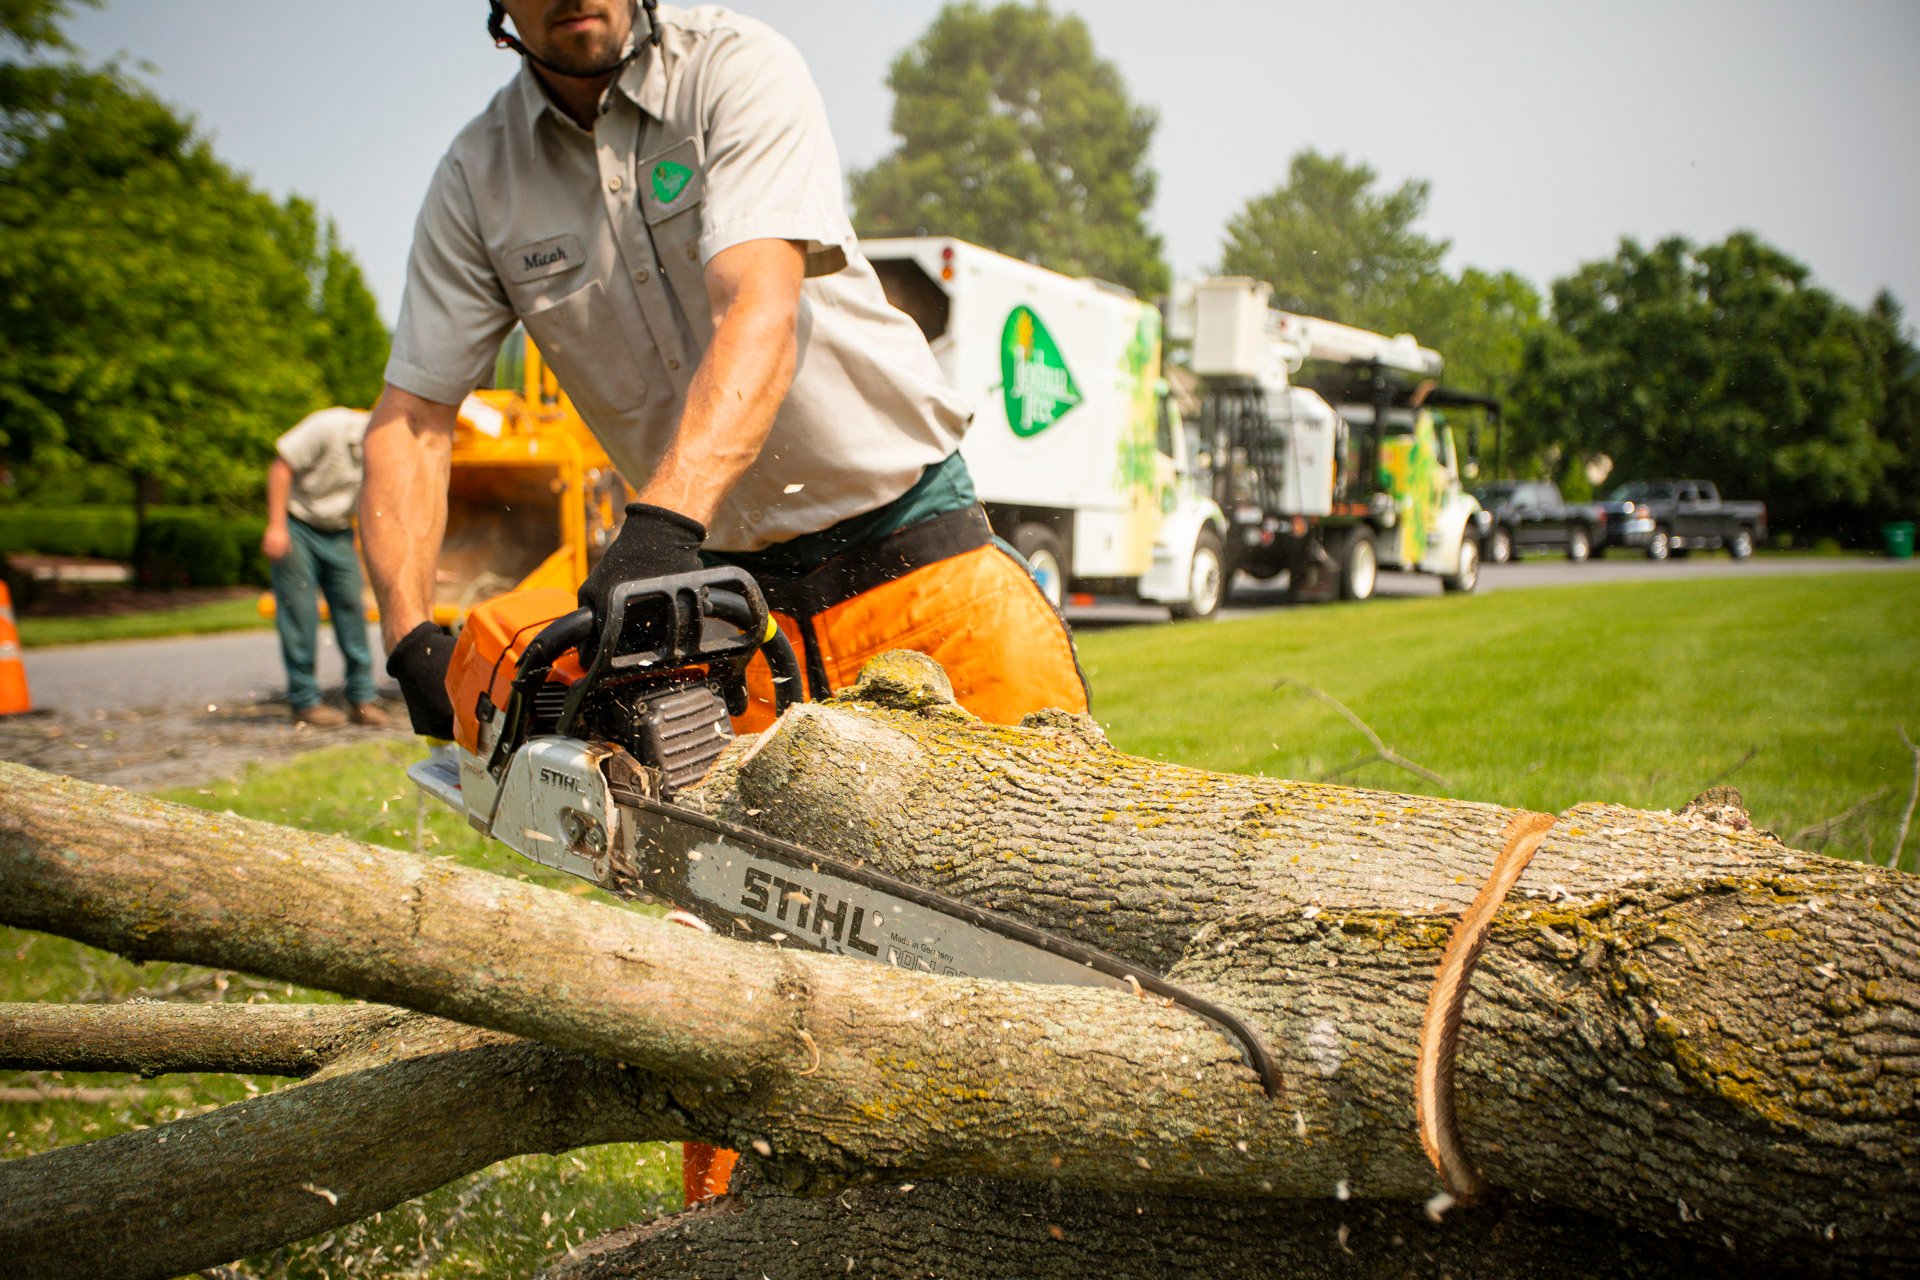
top-left (0, 574), bottom-right (1920, 1280)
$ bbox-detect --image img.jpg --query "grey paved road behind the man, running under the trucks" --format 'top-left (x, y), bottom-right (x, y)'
top-left (27, 555), bottom-right (1920, 716)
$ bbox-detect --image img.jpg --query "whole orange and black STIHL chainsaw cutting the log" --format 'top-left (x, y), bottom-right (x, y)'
top-left (407, 568), bottom-right (1279, 1096)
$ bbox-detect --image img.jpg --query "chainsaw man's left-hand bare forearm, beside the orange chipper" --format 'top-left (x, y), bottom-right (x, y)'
top-left (359, 386), bottom-right (457, 649)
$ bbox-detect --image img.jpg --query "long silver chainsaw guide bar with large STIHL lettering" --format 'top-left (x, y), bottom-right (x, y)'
top-left (611, 787), bottom-right (1281, 1098)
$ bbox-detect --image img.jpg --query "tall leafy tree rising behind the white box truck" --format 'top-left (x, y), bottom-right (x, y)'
top-left (852, 2), bottom-right (1169, 296)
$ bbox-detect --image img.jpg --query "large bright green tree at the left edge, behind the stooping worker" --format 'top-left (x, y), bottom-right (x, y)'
top-left (0, 2), bottom-right (386, 518)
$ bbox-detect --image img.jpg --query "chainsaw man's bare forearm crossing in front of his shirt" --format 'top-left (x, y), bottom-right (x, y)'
top-left (639, 240), bottom-right (804, 524)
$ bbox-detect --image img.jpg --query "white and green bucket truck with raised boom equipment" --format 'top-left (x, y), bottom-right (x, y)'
top-left (1171, 276), bottom-right (1498, 599)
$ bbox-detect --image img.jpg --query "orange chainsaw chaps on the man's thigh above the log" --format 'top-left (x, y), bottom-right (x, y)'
top-left (733, 545), bottom-right (1087, 733)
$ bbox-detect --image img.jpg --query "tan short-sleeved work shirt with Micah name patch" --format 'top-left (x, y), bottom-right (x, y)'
top-left (386, 6), bottom-right (970, 551)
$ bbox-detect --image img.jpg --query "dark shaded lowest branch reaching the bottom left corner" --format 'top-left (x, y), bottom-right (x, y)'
top-left (0, 1009), bottom-right (687, 1280)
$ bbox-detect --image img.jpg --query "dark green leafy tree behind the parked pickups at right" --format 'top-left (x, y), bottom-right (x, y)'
top-left (1523, 232), bottom-right (1899, 533)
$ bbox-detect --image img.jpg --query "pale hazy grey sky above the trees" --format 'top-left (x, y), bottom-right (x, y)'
top-left (73, 0), bottom-right (1920, 320)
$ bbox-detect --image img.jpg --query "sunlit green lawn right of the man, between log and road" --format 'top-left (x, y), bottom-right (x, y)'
top-left (1079, 572), bottom-right (1920, 865)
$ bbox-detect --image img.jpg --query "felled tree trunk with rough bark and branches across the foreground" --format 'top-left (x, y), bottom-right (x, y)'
top-left (0, 654), bottom-right (1920, 1278)
